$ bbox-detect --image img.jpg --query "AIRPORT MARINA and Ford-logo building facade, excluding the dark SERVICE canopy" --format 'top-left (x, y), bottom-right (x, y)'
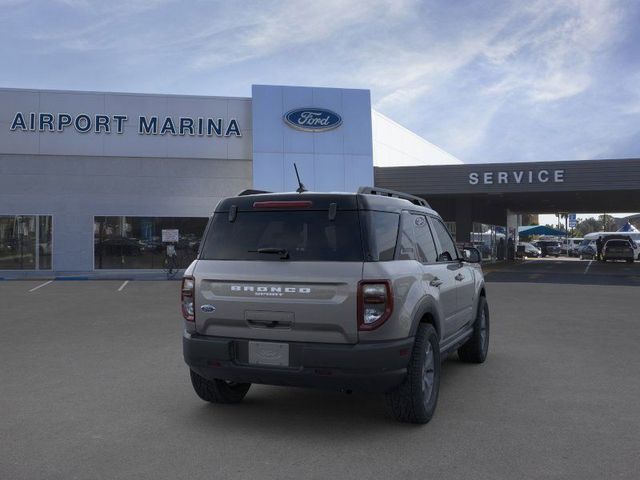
top-left (0, 85), bottom-right (461, 278)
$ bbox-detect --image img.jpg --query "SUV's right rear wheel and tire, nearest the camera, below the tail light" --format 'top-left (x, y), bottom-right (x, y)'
top-left (386, 323), bottom-right (442, 423)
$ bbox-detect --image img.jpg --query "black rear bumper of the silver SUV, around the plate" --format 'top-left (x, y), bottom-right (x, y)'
top-left (182, 332), bottom-right (414, 392)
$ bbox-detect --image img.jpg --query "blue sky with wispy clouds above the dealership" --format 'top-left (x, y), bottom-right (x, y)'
top-left (0, 0), bottom-right (640, 163)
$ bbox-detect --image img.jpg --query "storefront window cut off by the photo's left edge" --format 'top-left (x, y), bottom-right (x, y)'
top-left (0, 215), bottom-right (53, 270)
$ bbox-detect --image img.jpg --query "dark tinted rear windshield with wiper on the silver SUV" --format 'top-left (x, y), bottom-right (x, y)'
top-left (200, 210), bottom-right (364, 262)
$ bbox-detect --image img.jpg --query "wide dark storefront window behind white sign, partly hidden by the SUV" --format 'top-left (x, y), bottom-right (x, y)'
top-left (94, 217), bottom-right (209, 269)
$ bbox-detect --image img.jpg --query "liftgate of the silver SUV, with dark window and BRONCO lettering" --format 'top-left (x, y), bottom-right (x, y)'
top-left (194, 206), bottom-right (363, 343)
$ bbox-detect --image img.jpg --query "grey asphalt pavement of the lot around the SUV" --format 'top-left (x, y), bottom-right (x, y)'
top-left (0, 260), bottom-right (640, 480)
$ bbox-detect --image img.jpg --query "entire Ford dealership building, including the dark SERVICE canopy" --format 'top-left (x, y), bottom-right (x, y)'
top-left (0, 85), bottom-right (640, 278)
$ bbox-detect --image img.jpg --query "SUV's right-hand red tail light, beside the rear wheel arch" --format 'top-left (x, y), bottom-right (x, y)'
top-left (358, 280), bottom-right (393, 330)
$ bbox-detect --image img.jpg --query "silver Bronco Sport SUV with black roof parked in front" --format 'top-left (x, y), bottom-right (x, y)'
top-left (181, 188), bottom-right (489, 423)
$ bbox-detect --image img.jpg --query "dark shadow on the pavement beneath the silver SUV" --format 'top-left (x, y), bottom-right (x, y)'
top-left (184, 354), bottom-right (478, 441)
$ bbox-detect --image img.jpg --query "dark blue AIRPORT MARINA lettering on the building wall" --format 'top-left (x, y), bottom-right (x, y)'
top-left (10, 112), bottom-right (242, 137)
